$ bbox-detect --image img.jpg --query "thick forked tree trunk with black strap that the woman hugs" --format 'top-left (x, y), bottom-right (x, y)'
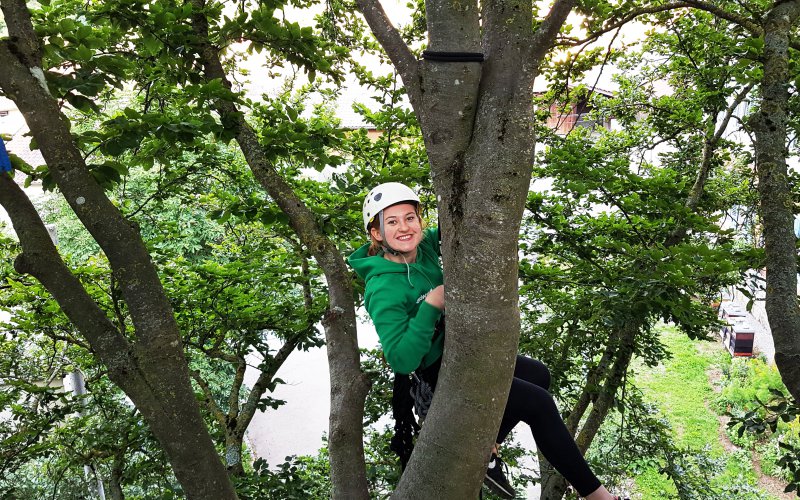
top-left (358, 0), bottom-right (573, 499)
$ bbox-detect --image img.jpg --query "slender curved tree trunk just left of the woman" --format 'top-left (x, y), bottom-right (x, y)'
top-left (192, 0), bottom-right (369, 500)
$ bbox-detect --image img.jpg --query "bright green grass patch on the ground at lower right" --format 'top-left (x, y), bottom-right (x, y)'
top-left (634, 326), bottom-right (772, 499)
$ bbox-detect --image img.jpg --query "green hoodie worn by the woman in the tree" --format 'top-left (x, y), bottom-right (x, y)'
top-left (347, 228), bottom-right (444, 373)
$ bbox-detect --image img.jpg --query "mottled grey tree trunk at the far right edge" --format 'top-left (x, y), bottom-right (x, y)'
top-left (751, 0), bottom-right (800, 401)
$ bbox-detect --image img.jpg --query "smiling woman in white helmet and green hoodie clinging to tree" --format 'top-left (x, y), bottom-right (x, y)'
top-left (348, 182), bottom-right (619, 500)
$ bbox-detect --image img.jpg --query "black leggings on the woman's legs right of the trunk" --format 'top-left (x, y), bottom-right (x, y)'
top-left (497, 355), bottom-right (600, 497)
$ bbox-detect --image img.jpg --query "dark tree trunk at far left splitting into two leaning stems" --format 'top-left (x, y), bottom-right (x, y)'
top-left (0, 0), bottom-right (236, 499)
